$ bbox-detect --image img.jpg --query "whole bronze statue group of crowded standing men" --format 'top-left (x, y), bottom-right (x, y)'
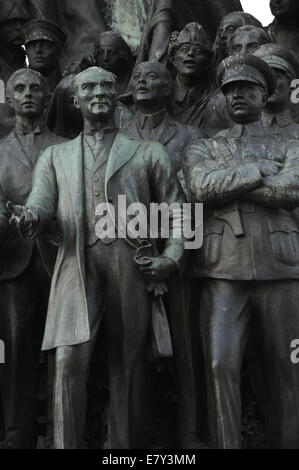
top-left (0, 0), bottom-right (299, 449)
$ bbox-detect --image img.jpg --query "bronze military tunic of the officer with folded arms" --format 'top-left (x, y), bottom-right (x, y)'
top-left (184, 123), bottom-right (299, 281)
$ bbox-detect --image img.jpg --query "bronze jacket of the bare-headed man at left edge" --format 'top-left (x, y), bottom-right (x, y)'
top-left (0, 126), bottom-right (65, 280)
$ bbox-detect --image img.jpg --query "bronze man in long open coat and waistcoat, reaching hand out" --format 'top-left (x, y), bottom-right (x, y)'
top-left (11, 67), bottom-right (184, 449)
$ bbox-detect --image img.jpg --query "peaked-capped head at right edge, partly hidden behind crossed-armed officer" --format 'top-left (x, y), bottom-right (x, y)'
top-left (253, 43), bottom-right (299, 113)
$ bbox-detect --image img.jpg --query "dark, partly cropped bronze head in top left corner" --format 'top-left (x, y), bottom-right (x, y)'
top-left (0, 0), bottom-right (31, 47)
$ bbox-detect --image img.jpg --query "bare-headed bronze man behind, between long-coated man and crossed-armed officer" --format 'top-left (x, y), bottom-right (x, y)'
top-left (122, 58), bottom-right (204, 449)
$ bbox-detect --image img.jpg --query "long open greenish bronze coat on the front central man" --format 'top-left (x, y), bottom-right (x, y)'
top-left (27, 133), bottom-right (184, 350)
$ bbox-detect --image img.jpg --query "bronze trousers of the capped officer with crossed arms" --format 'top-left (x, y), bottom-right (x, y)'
top-left (201, 279), bottom-right (299, 449)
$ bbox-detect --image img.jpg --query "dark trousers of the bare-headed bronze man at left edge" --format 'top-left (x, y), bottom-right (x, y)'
top-left (0, 253), bottom-right (45, 448)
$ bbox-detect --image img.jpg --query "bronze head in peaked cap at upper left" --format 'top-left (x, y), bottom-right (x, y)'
top-left (23, 20), bottom-right (66, 75)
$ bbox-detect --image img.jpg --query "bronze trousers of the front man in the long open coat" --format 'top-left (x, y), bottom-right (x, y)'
top-left (54, 240), bottom-right (155, 449)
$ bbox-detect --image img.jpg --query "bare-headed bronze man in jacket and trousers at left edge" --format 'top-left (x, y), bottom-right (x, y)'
top-left (0, 69), bottom-right (64, 448)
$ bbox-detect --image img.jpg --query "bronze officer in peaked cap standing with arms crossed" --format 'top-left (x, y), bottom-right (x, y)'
top-left (184, 55), bottom-right (299, 449)
